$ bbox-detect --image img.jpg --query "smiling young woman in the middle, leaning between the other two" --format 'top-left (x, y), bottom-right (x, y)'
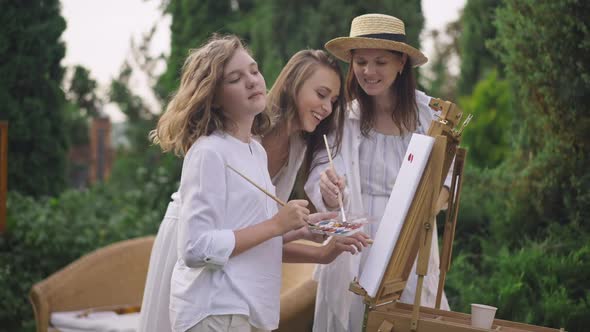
top-left (262, 50), bottom-right (368, 264)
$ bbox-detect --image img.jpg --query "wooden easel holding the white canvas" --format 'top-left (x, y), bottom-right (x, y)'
top-left (350, 99), bottom-right (558, 332)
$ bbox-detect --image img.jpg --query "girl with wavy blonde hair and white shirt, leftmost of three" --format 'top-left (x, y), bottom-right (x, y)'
top-left (148, 36), bottom-right (309, 332)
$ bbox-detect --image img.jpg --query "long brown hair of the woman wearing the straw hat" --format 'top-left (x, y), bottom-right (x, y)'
top-left (346, 51), bottom-right (418, 136)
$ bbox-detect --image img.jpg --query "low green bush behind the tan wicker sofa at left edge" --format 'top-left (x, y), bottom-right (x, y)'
top-left (0, 154), bottom-right (179, 331)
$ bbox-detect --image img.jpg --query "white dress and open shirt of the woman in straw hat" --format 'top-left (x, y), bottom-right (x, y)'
top-left (305, 91), bottom-right (450, 332)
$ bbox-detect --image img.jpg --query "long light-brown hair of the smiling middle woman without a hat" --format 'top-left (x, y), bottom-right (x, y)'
top-left (266, 50), bottom-right (345, 174)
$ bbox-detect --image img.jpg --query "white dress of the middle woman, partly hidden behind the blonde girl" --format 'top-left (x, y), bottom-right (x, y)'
top-left (137, 136), bottom-right (306, 332)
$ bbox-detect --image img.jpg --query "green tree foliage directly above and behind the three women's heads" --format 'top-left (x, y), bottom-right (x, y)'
top-left (158, 0), bottom-right (424, 98)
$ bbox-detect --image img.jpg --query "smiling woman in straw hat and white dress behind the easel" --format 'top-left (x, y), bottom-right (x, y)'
top-left (305, 14), bottom-right (450, 332)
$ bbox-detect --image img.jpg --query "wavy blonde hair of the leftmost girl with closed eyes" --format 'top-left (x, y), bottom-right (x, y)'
top-left (149, 35), bottom-right (270, 156)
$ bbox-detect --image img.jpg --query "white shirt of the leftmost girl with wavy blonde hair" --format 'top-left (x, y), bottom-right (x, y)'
top-left (170, 132), bottom-right (283, 332)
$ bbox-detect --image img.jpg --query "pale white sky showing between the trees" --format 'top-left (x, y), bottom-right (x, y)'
top-left (62, 0), bottom-right (465, 122)
